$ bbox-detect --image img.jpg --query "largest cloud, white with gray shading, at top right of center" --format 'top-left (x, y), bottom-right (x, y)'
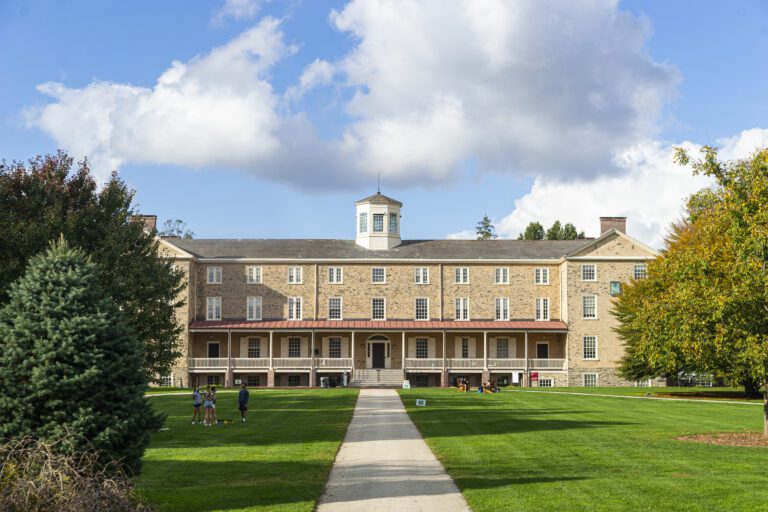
top-left (331, 0), bottom-right (679, 180)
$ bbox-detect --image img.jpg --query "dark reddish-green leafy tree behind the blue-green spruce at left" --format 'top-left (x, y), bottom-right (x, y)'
top-left (0, 152), bottom-right (184, 379)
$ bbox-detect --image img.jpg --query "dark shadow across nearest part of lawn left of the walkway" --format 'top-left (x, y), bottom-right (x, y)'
top-left (135, 460), bottom-right (331, 512)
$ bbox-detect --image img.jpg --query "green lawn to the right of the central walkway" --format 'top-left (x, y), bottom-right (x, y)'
top-left (401, 388), bottom-right (768, 512)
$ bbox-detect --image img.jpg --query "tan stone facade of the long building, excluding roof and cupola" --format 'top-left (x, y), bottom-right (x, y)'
top-left (161, 202), bottom-right (656, 387)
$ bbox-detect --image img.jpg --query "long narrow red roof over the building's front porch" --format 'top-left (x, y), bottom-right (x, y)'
top-left (189, 320), bottom-right (568, 331)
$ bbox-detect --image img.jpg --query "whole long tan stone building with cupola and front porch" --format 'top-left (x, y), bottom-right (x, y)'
top-left (153, 193), bottom-right (657, 386)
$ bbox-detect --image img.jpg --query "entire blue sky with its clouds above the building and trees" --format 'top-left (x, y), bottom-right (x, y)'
top-left (0, 0), bottom-right (768, 244)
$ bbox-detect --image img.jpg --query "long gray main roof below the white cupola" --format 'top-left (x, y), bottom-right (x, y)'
top-left (166, 239), bottom-right (591, 260)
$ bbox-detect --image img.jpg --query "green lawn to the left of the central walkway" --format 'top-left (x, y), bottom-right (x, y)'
top-left (136, 389), bottom-right (357, 512)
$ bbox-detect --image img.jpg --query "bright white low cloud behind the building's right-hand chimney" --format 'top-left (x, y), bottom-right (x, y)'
top-left (497, 128), bottom-right (768, 247)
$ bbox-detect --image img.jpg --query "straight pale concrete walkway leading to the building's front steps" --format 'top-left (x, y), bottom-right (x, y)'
top-left (317, 389), bottom-right (470, 512)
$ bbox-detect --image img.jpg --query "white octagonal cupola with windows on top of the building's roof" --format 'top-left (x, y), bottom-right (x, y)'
top-left (355, 192), bottom-right (403, 251)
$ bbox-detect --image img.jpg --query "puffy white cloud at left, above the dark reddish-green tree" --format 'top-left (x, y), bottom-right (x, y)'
top-left (28, 18), bottom-right (295, 182)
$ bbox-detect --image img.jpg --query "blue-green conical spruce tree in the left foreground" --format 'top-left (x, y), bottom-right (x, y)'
top-left (0, 238), bottom-right (162, 472)
